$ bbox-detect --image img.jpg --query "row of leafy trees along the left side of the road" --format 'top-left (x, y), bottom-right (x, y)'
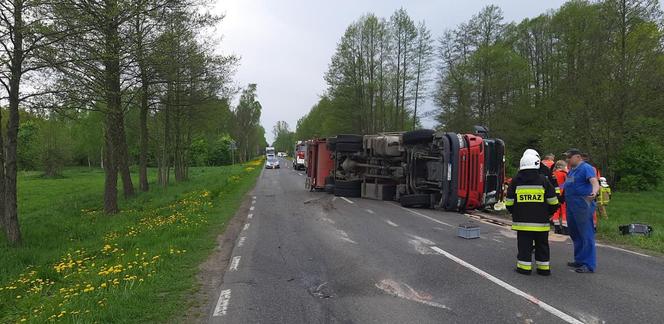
top-left (0, 0), bottom-right (265, 244)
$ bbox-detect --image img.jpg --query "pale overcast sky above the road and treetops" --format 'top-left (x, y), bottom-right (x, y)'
top-left (210, 0), bottom-right (565, 142)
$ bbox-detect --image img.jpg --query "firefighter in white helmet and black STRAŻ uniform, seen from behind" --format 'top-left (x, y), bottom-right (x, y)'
top-left (505, 156), bottom-right (558, 275)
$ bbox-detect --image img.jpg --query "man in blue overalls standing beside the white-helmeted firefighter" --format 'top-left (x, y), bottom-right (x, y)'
top-left (563, 149), bottom-right (599, 273)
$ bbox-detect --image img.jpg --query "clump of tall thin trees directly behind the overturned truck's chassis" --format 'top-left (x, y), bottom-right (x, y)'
top-left (296, 9), bottom-right (434, 139)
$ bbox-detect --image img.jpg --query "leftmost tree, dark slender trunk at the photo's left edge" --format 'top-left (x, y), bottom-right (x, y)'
top-left (0, 0), bottom-right (69, 244)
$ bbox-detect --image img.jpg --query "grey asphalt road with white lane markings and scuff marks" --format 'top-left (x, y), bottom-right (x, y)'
top-left (208, 160), bottom-right (664, 323)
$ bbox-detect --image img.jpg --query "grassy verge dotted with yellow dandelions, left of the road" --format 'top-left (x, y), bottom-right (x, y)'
top-left (0, 161), bottom-right (262, 323)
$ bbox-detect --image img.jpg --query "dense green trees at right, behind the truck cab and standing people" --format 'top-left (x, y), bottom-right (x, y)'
top-left (433, 0), bottom-right (664, 190)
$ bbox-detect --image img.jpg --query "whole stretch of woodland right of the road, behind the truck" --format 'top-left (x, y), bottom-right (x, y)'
top-left (290, 0), bottom-right (664, 191)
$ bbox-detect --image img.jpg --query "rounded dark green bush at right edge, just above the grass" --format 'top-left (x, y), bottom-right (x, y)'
top-left (615, 136), bottom-right (664, 191)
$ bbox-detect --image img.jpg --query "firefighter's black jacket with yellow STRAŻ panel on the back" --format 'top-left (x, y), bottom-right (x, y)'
top-left (505, 170), bottom-right (559, 232)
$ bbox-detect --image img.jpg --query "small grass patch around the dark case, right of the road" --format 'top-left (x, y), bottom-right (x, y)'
top-left (597, 189), bottom-right (664, 253)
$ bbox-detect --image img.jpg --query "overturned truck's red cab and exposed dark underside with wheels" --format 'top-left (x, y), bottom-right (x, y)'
top-left (319, 126), bottom-right (505, 211)
